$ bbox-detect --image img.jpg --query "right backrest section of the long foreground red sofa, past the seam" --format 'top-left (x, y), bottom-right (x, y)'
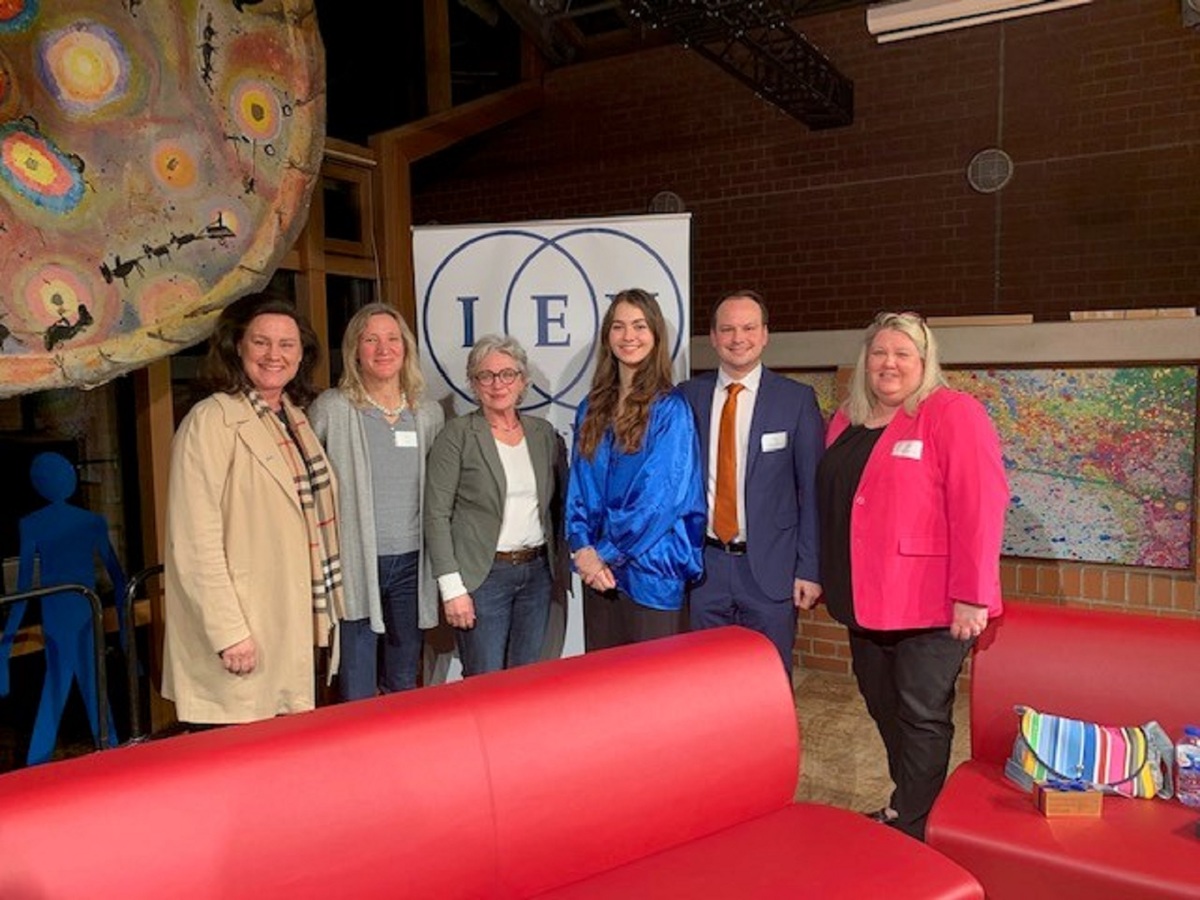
top-left (469, 626), bottom-right (799, 896)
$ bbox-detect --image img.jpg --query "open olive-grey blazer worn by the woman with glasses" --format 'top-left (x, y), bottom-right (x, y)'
top-left (425, 409), bottom-right (562, 592)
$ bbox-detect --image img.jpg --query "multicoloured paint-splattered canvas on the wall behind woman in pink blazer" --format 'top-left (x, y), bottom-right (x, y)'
top-left (947, 366), bottom-right (1198, 569)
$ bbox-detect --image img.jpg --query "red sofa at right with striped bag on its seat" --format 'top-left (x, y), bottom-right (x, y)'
top-left (925, 602), bottom-right (1200, 900)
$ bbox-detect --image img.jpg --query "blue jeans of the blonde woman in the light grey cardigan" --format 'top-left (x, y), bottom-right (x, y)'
top-left (337, 550), bottom-right (425, 700)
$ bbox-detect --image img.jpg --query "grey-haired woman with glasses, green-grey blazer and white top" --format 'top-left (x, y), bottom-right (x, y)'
top-left (425, 335), bottom-right (559, 676)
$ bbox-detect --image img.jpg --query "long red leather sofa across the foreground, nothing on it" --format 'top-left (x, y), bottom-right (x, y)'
top-left (0, 628), bottom-right (983, 900)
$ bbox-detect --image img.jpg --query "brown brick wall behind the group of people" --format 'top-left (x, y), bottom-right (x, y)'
top-left (414, 0), bottom-right (1200, 671)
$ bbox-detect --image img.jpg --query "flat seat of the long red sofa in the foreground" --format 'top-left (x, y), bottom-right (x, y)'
top-left (538, 803), bottom-right (983, 900)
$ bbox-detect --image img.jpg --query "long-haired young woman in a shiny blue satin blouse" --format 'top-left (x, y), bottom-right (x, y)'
top-left (566, 288), bottom-right (707, 650)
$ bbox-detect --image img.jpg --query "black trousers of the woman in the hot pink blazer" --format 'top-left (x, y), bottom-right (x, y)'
top-left (850, 628), bottom-right (973, 840)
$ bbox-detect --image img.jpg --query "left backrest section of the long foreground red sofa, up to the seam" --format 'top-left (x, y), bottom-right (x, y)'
top-left (0, 684), bottom-right (494, 900)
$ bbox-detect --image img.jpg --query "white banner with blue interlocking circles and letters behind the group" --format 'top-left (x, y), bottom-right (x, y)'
top-left (413, 214), bottom-right (691, 655)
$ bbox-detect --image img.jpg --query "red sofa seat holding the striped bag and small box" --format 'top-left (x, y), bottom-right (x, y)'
top-left (925, 762), bottom-right (1200, 900)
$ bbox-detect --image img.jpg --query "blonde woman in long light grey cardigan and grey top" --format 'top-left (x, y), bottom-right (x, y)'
top-left (308, 304), bottom-right (443, 700)
